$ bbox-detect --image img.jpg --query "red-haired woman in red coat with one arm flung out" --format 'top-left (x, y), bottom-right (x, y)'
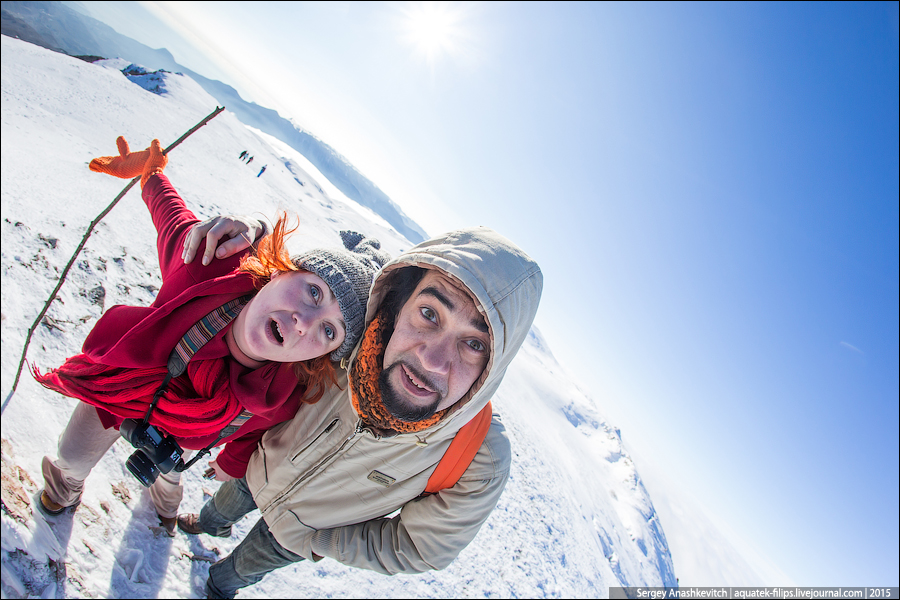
top-left (34, 137), bottom-right (389, 535)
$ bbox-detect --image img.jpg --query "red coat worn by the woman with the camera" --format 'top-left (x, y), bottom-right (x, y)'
top-left (36, 174), bottom-right (306, 477)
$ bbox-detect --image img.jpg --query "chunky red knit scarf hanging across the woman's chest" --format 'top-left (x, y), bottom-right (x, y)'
top-left (32, 354), bottom-right (242, 437)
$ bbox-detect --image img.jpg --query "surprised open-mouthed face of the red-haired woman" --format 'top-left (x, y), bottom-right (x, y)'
top-left (232, 271), bottom-right (346, 364)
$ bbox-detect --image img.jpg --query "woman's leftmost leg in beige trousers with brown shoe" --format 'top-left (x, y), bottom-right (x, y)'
top-left (41, 402), bottom-right (119, 506)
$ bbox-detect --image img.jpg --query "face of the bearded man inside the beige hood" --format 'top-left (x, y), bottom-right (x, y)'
top-left (379, 269), bottom-right (491, 421)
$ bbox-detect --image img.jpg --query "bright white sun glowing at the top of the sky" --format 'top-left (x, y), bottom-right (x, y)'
top-left (403, 2), bottom-right (463, 64)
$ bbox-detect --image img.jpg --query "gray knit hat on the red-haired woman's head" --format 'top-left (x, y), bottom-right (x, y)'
top-left (291, 231), bottom-right (391, 361)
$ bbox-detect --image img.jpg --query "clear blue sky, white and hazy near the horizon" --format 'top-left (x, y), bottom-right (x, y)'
top-left (84, 2), bottom-right (900, 586)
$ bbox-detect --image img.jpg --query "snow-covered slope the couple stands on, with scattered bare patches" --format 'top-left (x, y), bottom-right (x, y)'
top-left (0, 36), bottom-right (675, 598)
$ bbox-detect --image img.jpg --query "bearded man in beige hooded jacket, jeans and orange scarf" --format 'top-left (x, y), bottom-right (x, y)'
top-left (178, 211), bottom-right (543, 598)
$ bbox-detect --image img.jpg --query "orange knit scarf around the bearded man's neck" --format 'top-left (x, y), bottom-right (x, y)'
top-left (350, 313), bottom-right (448, 433)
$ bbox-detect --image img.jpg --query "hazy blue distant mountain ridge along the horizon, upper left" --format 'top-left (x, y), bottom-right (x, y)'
top-left (2, 1), bottom-right (428, 243)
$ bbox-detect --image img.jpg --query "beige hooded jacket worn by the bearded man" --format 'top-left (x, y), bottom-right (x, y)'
top-left (247, 227), bottom-right (543, 574)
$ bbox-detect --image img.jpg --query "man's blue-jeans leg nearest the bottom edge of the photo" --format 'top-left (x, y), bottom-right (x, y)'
top-left (206, 518), bottom-right (303, 598)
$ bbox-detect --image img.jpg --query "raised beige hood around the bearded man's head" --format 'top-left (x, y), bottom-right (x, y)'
top-left (350, 227), bottom-right (543, 438)
